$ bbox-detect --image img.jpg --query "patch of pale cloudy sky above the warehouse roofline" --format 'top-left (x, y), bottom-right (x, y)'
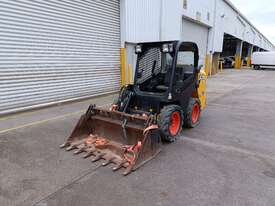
top-left (231, 0), bottom-right (275, 45)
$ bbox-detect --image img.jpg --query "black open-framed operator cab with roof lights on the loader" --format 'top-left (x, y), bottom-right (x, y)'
top-left (135, 41), bottom-right (198, 95)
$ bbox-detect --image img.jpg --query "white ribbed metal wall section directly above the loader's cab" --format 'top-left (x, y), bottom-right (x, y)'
top-left (124, 0), bottom-right (182, 43)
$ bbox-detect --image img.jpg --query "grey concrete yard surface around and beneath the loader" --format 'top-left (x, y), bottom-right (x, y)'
top-left (0, 70), bottom-right (275, 206)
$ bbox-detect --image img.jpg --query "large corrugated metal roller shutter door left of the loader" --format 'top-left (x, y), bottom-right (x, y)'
top-left (0, 0), bottom-right (120, 114)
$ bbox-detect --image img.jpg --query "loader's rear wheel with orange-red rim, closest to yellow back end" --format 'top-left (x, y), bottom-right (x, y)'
top-left (184, 98), bottom-right (201, 128)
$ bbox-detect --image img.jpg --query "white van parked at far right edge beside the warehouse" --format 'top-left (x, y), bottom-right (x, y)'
top-left (252, 52), bottom-right (275, 69)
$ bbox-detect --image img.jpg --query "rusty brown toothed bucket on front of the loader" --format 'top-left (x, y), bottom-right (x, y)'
top-left (60, 105), bottom-right (161, 175)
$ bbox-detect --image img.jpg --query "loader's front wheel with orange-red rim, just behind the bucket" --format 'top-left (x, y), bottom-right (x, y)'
top-left (159, 105), bottom-right (183, 143)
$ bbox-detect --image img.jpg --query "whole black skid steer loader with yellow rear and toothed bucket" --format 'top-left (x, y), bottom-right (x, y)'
top-left (60, 41), bottom-right (206, 175)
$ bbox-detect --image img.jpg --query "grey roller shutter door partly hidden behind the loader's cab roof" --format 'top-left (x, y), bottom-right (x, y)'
top-left (182, 19), bottom-right (209, 65)
